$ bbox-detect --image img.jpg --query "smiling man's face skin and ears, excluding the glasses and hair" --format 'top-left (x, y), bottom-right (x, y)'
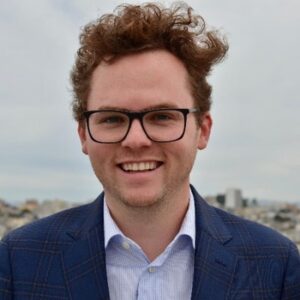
top-left (78, 50), bottom-right (211, 207)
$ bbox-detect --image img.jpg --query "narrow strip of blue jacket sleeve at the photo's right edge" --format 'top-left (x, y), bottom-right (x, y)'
top-left (281, 243), bottom-right (300, 300)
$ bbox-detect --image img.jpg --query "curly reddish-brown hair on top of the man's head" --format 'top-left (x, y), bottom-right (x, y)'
top-left (71, 2), bottom-right (228, 121)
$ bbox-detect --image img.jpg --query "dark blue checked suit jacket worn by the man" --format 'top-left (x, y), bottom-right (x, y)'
top-left (0, 188), bottom-right (300, 300)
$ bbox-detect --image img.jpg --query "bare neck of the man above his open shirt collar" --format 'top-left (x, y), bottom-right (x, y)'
top-left (106, 191), bottom-right (189, 261)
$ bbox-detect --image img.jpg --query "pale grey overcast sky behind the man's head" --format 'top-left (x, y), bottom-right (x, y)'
top-left (0, 0), bottom-right (300, 202)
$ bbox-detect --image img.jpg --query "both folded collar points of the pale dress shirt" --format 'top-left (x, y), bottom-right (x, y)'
top-left (103, 190), bottom-right (196, 249)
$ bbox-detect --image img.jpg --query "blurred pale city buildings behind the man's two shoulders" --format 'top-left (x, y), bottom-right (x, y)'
top-left (0, 188), bottom-right (300, 250)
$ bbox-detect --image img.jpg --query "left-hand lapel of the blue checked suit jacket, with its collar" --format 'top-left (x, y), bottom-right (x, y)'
top-left (62, 195), bottom-right (109, 300)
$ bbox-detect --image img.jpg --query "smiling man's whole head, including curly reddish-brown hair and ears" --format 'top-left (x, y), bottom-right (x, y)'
top-left (72, 3), bottom-right (227, 212)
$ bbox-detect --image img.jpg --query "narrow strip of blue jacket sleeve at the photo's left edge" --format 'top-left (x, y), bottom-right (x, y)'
top-left (0, 240), bottom-right (13, 300)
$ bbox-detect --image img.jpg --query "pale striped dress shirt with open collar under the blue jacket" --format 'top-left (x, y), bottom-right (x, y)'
top-left (104, 192), bottom-right (195, 300)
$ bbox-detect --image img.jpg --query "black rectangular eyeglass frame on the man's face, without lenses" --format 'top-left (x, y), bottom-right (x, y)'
top-left (83, 108), bottom-right (200, 144)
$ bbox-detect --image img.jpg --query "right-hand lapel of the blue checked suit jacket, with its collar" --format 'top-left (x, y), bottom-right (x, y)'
top-left (192, 187), bottom-right (237, 300)
